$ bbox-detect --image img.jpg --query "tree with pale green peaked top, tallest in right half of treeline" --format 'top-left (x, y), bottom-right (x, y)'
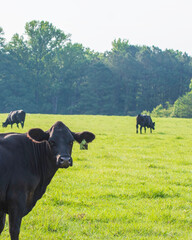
top-left (108, 39), bottom-right (140, 115)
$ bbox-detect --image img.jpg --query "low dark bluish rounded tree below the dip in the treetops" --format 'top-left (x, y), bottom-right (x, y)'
top-left (78, 59), bottom-right (116, 114)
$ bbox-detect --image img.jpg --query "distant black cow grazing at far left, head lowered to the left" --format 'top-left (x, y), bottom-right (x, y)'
top-left (2, 110), bottom-right (26, 128)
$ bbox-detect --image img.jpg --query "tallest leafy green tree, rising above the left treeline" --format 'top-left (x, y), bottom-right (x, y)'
top-left (25, 21), bottom-right (70, 111)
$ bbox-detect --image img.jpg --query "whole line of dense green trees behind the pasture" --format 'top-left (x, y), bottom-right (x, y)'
top-left (0, 21), bottom-right (192, 115)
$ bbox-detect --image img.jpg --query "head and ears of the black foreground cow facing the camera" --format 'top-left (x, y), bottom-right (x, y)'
top-left (27, 121), bottom-right (95, 168)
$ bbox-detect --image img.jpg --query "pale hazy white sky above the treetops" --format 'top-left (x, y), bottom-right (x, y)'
top-left (0, 0), bottom-right (192, 56)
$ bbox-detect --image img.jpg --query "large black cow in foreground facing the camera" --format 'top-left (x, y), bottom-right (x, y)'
top-left (0, 121), bottom-right (95, 240)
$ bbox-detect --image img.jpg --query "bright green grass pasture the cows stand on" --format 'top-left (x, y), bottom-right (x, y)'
top-left (0, 114), bottom-right (192, 240)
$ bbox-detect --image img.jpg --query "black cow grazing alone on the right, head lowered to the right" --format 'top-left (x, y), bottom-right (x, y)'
top-left (136, 114), bottom-right (155, 133)
